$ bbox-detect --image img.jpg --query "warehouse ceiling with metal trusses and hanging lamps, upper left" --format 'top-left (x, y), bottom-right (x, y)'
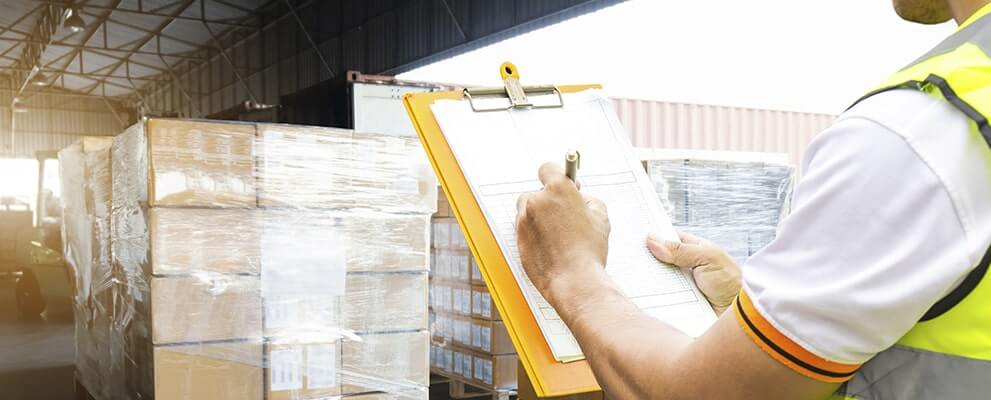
top-left (0, 0), bottom-right (270, 97)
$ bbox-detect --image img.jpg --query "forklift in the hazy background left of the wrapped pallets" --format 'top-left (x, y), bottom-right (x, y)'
top-left (6, 151), bottom-right (74, 318)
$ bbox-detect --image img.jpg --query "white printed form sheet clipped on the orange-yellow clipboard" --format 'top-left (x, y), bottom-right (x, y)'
top-left (431, 90), bottom-right (716, 362)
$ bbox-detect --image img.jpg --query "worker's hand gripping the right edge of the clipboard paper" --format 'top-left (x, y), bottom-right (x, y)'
top-left (647, 231), bottom-right (741, 314)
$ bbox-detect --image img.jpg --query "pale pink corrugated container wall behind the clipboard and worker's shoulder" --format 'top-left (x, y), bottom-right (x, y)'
top-left (613, 99), bottom-right (836, 172)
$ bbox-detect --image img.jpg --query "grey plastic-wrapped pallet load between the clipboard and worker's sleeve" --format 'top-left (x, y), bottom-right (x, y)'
top-left (638, 149), bottom-right (795, 265)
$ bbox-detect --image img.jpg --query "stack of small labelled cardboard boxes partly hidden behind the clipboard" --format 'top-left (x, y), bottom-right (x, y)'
top-left (430, 194), bottom-right (519, 392)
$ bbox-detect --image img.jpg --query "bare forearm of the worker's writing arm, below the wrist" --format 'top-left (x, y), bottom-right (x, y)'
top-left (548, 270), bottom-right (692, 399)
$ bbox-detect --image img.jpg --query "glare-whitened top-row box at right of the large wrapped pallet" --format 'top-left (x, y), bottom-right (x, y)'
top-left (259, 124), bottom-right (437, 214)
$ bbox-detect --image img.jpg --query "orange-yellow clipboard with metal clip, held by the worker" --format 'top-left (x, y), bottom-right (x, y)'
top-left (403, 63), bottom-right (601, 397)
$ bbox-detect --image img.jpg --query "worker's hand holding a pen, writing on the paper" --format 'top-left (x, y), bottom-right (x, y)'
top-left (516, 163), bottom-right (609, 304)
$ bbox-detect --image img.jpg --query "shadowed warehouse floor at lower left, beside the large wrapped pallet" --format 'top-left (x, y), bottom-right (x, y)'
top-left (0, 280), bottom-right (75, 400)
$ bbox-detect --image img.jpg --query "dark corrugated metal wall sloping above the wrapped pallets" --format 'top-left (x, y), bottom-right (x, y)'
top-left (144, 0), bottom-right (621, 117)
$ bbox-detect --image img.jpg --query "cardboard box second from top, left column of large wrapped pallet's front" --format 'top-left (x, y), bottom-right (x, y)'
top-left (148, 208), bottom-right (262, 275)
